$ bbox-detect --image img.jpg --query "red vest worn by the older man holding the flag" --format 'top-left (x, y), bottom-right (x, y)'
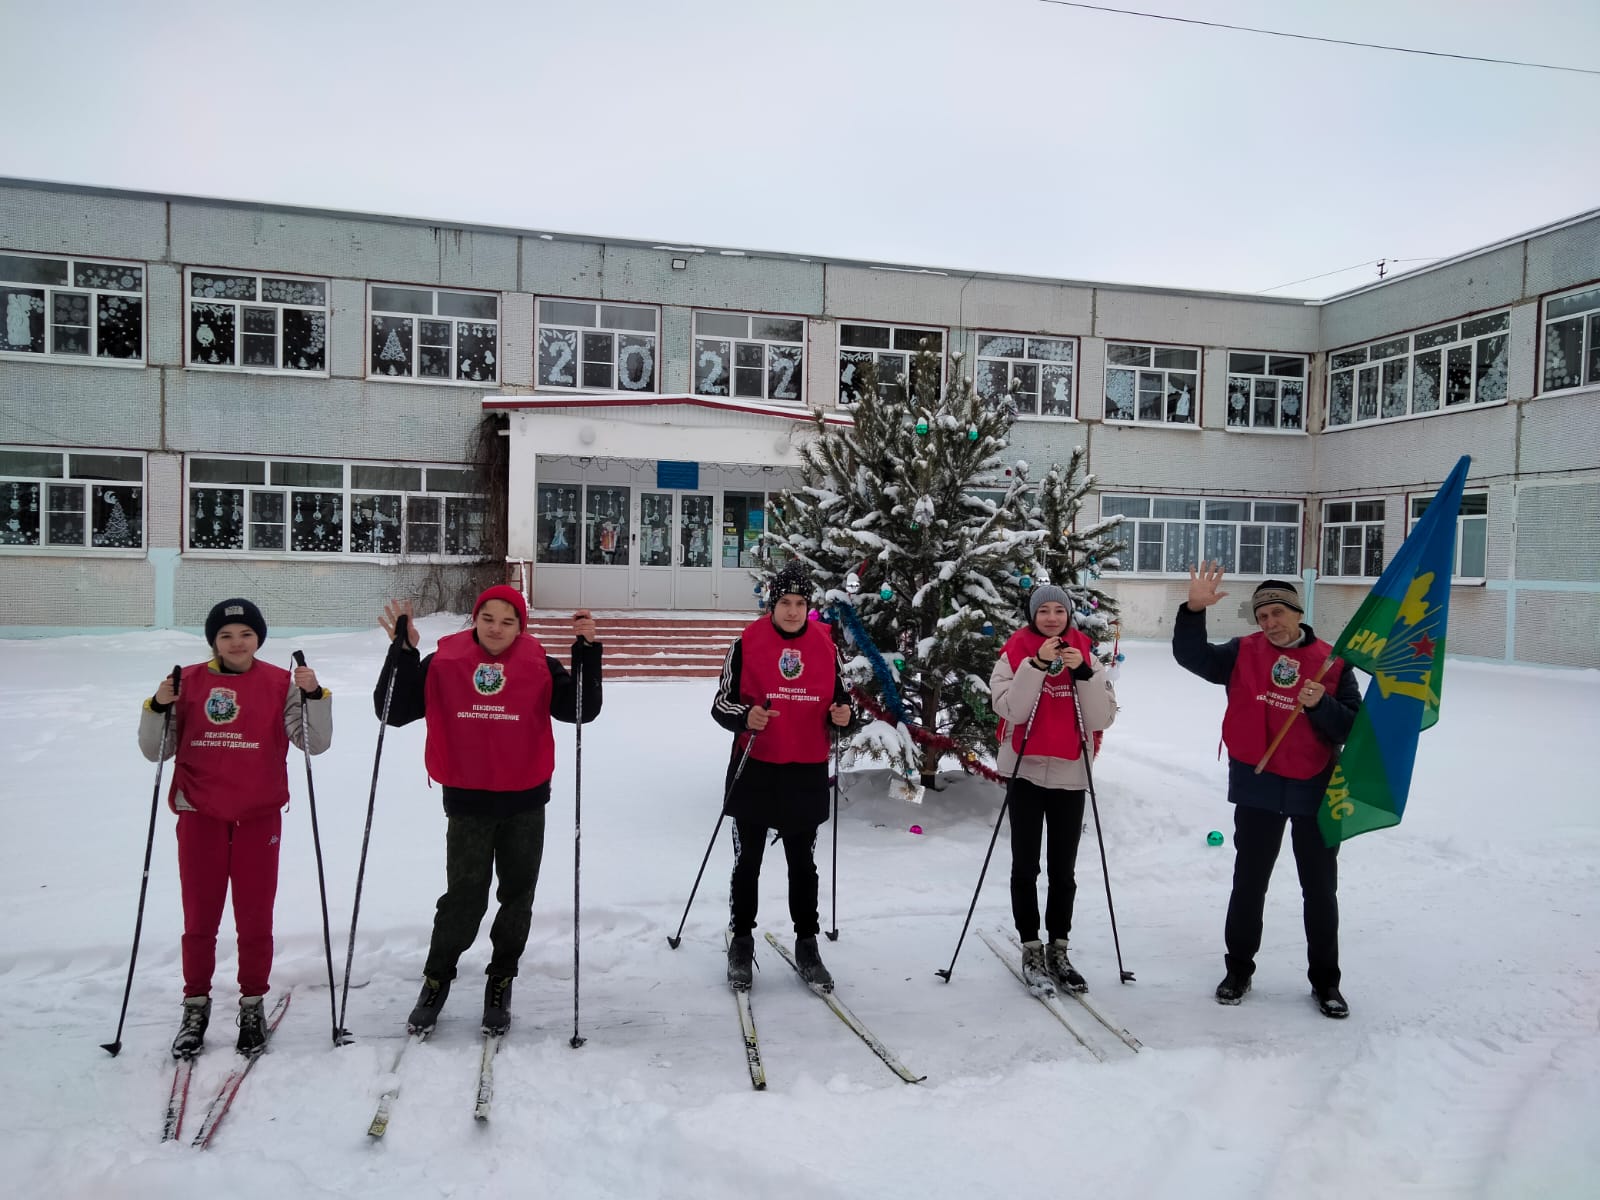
top-left (1222, 634), bottom-right (1344, 779)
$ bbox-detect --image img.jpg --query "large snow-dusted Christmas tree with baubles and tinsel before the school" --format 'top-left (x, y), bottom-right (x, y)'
top-left (768, 349), bottom-right (1115, 790)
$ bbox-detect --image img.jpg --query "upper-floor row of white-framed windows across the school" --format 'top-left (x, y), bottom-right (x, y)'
top-left (0, 254), bottom-right (1600, 432)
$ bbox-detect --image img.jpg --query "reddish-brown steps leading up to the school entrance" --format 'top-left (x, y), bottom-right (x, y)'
top-left (528, 611), bottom-right (755, 681)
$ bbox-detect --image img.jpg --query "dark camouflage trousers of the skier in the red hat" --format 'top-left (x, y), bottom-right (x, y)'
top-left (422, 805), bottom-right (544, 979)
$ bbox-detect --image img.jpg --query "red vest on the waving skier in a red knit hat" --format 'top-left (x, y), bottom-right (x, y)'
top-left (422, 629), bottom-right (555, 792)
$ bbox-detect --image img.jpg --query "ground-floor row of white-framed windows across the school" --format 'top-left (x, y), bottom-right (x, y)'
top-left (9, 448), bottom-right (1488, 579)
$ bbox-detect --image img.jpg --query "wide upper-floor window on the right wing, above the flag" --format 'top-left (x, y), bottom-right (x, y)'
top-left (1325, 312), bottom-right (1510, 429)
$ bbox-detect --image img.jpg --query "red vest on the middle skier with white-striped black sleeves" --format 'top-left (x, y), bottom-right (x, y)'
top-left (739, 616), bottom-right (838, 763)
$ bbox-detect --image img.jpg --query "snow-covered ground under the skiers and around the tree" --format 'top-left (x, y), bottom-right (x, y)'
top-left (0, 618), bottom-right (1600, 1200)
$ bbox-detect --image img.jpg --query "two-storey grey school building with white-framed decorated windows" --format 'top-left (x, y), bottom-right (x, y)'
top-left (0, 179), bottom-right (1600, 667)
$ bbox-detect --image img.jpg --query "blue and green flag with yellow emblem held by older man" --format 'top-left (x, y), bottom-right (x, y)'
top-left (1317, 454), bottom-right (1472, 846)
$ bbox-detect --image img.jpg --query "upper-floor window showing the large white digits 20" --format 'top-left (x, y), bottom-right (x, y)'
top-left (534, 299), bottom-right (661, 392)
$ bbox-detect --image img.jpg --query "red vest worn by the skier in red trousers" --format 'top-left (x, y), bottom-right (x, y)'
top-left (166, 659), bottom-right (290, 821)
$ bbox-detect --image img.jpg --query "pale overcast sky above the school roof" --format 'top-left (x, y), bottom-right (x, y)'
top-left (0, 0), bottom-right (1600, 296)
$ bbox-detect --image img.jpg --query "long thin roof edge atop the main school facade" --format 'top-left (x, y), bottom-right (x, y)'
top-left (0, 176), bottom-right (1322, 307)
